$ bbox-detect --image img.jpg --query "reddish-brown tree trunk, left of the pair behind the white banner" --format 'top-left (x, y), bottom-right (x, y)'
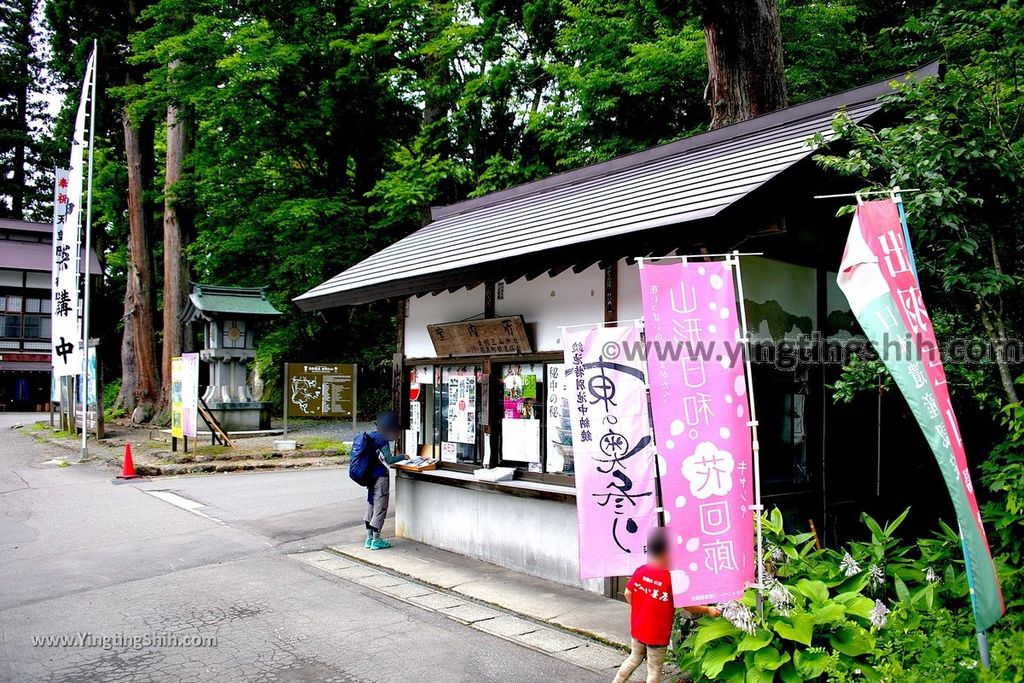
top-left (122, 112), bottom-right (160, 419)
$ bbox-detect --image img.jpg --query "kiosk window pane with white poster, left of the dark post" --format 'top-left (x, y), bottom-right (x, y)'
top-left (434, 366), bottom-right (483, 465)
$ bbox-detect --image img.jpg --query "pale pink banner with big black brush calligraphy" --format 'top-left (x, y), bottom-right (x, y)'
top-left (562, 326), bottom-right (657, 579)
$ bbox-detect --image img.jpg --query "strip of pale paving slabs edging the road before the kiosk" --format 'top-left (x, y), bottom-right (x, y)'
top-left (291, 550), bottom-right (624, 678)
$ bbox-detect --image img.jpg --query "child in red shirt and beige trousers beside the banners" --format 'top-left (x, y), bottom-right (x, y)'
top-left (614, 529), bottom-right (721, 683)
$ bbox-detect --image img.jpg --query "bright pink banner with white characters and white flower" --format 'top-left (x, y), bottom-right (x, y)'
top-left (640, 261), bottom-right (756, 606)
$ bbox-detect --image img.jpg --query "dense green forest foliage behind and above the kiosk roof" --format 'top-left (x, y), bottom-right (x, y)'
top-left (22, 0), bottom-right (958, 409)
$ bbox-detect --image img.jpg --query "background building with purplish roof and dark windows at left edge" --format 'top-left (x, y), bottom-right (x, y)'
top-left (0, 218), bottom-right (100, 412)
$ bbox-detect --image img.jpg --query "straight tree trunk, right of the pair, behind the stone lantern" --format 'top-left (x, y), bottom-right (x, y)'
top-left (161, 93), bottom-right (188, 411)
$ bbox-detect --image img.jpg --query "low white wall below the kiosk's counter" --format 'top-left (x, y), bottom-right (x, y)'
top-left (395, 477), bottom-right (604, 593)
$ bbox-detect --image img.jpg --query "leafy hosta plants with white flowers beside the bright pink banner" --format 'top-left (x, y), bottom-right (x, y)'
top-left (675, 509), bottom-right (966, 683)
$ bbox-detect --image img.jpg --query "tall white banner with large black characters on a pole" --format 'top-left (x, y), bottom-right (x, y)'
top-left (50, 53), bottom-right (95, 377)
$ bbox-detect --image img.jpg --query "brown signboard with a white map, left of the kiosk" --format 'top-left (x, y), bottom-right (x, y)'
top-left (285, 362), bottom-right (356, 418)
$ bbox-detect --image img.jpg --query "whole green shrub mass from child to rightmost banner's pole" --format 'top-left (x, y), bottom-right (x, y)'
top-left (675, 510), bottom-right (991, 683)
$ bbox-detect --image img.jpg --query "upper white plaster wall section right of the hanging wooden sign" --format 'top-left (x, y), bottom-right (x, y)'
top-left (495, 264), bottom-right (604, 351)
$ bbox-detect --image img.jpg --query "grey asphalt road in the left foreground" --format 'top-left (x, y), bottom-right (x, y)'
top-left (0, 414), bottom-right (602, 683)
